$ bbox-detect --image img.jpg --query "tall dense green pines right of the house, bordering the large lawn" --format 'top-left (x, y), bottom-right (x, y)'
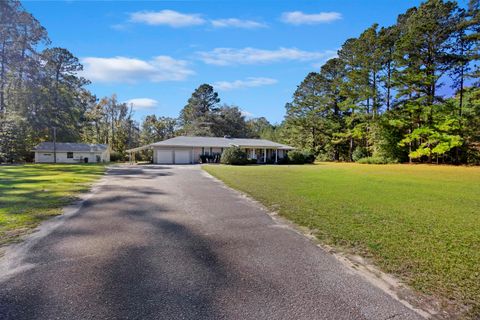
top-left (279, 0), bottom-right (480, 164)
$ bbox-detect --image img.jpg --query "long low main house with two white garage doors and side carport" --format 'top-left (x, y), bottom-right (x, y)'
top-left (127, 136), bottom-right (294, 164)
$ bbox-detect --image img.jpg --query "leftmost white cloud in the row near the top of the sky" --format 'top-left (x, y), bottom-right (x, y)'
top-left (130, 10), bottom-right (205, 28)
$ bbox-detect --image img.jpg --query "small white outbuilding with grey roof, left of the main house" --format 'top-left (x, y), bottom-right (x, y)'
top-left (33, 142), bottom-right (110, 163)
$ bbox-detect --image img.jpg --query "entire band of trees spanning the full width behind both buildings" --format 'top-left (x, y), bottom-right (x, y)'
top-left (0, 0), bottom-right (480, 164)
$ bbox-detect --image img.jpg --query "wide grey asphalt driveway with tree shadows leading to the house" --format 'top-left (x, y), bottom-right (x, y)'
top-left (0, 166), bottom-right (420, 320)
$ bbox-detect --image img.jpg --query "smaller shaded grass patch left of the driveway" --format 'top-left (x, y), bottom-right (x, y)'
top-left (0, 164), bottom-right (105, 245)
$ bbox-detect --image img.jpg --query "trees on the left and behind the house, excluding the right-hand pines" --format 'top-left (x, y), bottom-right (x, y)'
top-left (0, 0), bottom-right (269, 162)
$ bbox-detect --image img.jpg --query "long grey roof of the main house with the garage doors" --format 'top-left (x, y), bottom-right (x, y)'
top-left (150, 136), bottom-right (294, 150)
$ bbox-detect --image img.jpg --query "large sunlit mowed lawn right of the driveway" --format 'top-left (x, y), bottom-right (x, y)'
top-left (203, 163), bottom-right (480, 317)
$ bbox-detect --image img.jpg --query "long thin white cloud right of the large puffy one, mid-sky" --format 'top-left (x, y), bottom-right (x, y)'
top-left (197, 48), bottom-right (336, 66)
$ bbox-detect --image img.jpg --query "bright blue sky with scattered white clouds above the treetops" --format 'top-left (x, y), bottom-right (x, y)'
top-left (23, 0), bottom-right (464, 123)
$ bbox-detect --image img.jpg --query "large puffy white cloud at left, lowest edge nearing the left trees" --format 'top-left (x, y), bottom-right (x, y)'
top-left (81, 56), bottom-right (195, 83)
